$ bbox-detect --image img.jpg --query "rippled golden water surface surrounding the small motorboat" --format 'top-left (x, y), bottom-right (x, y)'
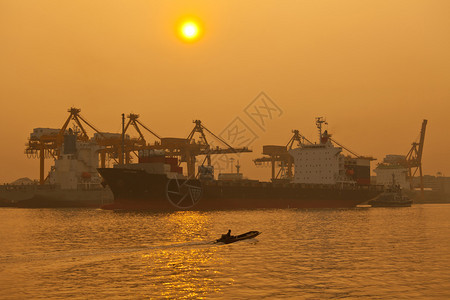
top-left (0, 204), bottom-right (450, 299)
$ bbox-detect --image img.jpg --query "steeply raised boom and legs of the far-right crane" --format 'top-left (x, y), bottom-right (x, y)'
top-left (406, 120), bottom-right (428, 194)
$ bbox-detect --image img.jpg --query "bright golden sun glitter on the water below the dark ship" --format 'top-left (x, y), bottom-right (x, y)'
top-left (142, 212), bottom-right (233, 299)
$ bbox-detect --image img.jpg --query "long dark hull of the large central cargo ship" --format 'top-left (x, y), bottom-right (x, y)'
top-left (98, 168), bottom-right (381, 211)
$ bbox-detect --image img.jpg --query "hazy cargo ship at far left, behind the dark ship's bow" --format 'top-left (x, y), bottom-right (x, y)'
top-left (0, 128), bottom-right (113, 208)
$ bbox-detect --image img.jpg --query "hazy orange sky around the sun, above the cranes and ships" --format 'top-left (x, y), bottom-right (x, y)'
top-left (0, 0), bottom-right (450, 182)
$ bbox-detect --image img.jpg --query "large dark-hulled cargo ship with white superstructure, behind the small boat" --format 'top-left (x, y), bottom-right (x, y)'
top-left (98, 118), bottom-right (383, 211)
